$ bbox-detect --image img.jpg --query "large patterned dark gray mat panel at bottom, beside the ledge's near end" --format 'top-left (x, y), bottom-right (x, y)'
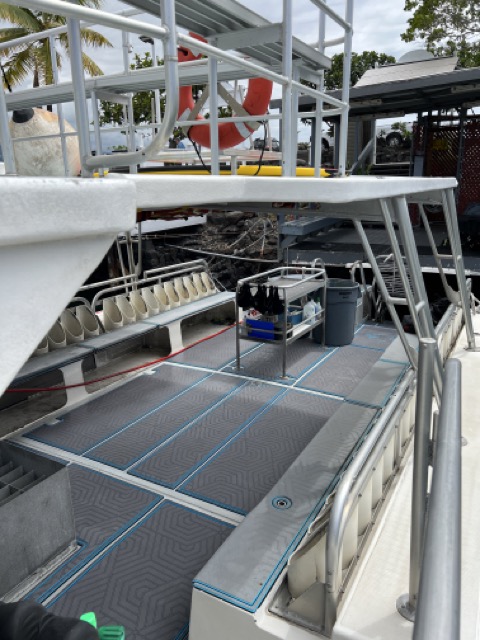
top-left (51, 501), bottom-right (232, 640)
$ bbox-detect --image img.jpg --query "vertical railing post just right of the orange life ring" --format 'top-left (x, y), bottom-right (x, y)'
top-left (281, 0), bottom-right (294, 176)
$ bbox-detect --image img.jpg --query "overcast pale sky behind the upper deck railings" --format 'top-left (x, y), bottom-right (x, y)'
top-left (8, 0), bottom-right (421, 140)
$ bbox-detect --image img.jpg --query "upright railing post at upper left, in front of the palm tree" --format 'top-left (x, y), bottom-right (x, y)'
top-left (67, 18), bottom-right (92, 178)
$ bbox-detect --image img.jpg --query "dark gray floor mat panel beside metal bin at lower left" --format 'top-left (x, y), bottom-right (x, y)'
top-left (29, 465), bottom-right (162, 602)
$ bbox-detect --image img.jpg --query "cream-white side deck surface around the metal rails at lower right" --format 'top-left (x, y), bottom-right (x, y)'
top-left (333, 315), bottom-right (480, 640)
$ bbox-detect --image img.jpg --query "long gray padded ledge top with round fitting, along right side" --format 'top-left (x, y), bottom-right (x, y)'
top-left (195, 402), bottom-right (377, 611)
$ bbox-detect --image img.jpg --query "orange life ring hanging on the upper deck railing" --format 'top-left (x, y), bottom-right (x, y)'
top-left (178, 33), bottom-right (273, 149)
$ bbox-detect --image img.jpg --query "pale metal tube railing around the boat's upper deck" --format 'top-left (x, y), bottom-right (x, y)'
top-left (0, 0), bottom-right (353, 176)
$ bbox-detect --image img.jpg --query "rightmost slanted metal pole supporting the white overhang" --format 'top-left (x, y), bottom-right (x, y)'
top-left (442, 189), bottom-right (475, 350)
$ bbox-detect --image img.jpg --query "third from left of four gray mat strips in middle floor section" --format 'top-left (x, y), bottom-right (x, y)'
top-left (130, 382), bottom-right (279, 487)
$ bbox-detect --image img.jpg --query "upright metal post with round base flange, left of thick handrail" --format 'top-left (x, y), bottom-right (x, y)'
top-left (397, 338), bottom-right (437, 622)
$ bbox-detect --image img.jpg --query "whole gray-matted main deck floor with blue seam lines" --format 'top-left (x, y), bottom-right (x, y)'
top-left (6, 324), bottom-right (408, 640)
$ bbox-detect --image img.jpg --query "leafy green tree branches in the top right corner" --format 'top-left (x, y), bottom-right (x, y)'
top-left (401, 0), bottom-right (480, 67)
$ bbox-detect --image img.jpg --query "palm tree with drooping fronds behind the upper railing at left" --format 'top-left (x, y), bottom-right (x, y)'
top-left (0, 0), bottom-right (112, 87)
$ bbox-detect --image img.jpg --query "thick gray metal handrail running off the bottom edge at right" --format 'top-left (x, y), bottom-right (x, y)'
top-left (413, 359), bottom-right (462, 640)
